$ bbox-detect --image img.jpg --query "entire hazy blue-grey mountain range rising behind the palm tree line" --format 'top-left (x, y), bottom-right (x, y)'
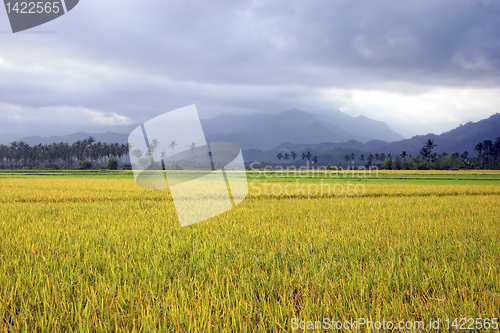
top-left (12, 109), bottom-right (500, 161)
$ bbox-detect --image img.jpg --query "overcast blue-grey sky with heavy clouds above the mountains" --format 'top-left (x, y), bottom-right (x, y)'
top-left (0, 0), bottom-right (500, 141)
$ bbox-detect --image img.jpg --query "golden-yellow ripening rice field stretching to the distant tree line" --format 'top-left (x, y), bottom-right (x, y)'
top-left (0, 171), bottom-right (500, 332)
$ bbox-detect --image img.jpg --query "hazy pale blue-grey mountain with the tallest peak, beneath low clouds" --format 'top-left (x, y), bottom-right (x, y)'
top-left (202, 109), bottom-right (403, 150)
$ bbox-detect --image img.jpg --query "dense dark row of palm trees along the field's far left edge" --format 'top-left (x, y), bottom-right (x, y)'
top-left (0, 136), bottom-right (129, 169)
